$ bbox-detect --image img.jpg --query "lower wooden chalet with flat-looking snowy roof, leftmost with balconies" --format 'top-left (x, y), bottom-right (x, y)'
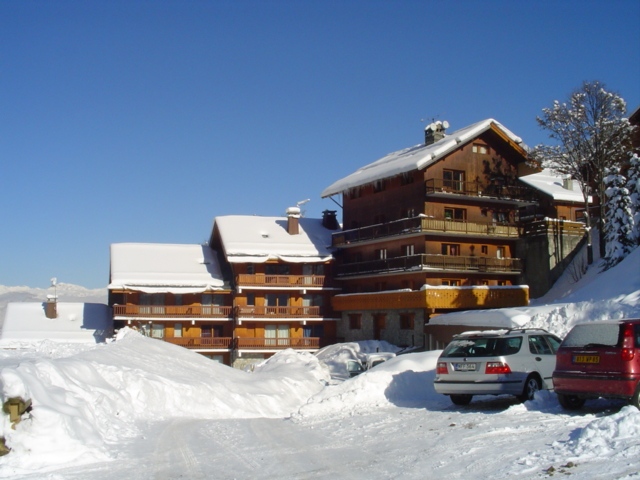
top-left (109, 243), bottom-right (234, 365)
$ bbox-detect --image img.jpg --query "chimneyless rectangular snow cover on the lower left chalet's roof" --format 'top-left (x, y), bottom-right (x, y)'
top-left (109, 243), bottom-right (224, 293)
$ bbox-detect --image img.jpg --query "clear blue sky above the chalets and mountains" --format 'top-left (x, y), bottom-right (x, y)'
top-left (0, 0), bottom-right (640, 288)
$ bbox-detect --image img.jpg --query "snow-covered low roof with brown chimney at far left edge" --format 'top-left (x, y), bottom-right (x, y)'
top-left (0, 302), bottom-right (113, 346)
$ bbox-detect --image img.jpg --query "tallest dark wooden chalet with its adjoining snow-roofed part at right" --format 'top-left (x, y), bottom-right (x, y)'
top-left (322, 119), bottom-right (584, 347)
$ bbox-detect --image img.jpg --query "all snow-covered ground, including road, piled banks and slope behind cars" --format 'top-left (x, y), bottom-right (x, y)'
top-left (0, 249), bottom-right (640, 480)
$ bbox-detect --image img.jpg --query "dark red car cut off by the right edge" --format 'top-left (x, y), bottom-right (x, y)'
top-left (553, 319), bottom-right (640, 410)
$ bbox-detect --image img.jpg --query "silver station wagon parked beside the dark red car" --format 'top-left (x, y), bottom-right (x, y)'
top-left (434, 329), bottom-right (561, 405)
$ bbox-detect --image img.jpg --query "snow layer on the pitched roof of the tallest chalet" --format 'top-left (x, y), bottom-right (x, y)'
top-left (321, 118), bottom-right (526, 198)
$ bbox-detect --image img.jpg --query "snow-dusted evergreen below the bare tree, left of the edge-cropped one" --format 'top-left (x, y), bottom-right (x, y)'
top-left (604, 169), bottom-right (636, 269)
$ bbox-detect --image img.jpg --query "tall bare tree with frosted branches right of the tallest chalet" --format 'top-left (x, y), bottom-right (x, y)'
top-left (532, 81), bottom-right (634, 264)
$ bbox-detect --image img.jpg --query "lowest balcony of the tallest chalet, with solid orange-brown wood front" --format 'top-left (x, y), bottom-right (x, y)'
top-left (332, 285), bottom-right (529, 311)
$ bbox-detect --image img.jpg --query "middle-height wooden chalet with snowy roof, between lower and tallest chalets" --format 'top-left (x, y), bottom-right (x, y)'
top-left (209, 207), bottom-right (339, 367)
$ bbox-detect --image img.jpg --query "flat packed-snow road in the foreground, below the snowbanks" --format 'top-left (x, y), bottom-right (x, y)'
top-left (15, 394), bottom-right (640, 480)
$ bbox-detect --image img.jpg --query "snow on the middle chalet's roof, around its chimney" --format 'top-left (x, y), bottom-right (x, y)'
top-left (215, 215), bottom-right (333, 263)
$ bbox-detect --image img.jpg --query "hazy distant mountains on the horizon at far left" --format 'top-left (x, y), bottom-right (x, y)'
top-left (0, 283), bottom-right (107, 325)
